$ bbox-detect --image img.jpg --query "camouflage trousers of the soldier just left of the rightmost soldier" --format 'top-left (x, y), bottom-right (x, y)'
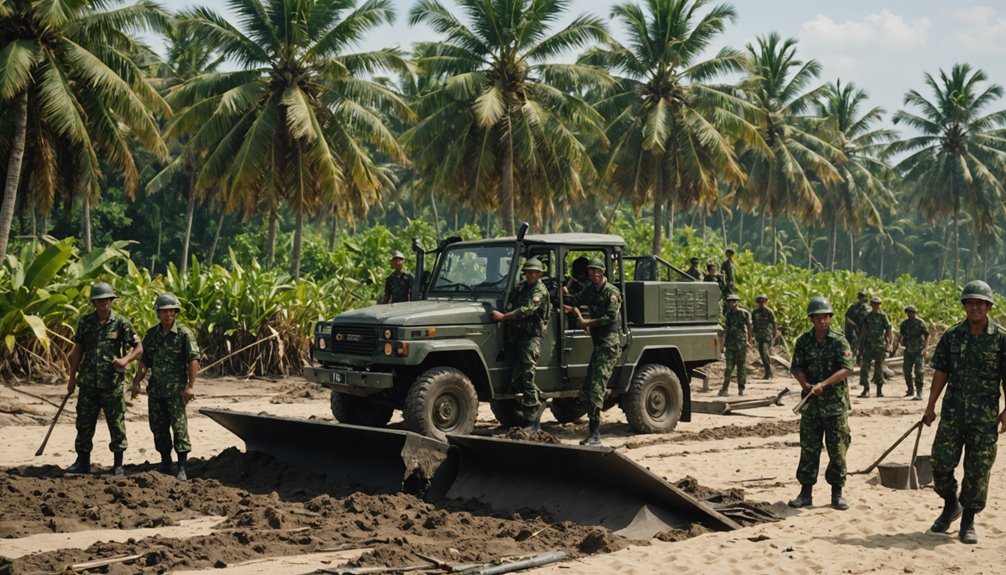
top-left (797, 413), bottom-right (852, 488)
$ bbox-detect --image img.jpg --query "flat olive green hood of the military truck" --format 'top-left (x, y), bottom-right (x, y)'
top-left (333, 300), bottom-right (492, 326)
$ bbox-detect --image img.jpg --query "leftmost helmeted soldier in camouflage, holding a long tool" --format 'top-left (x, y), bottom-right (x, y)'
top-left (66, 281), bottom-right (143, 475)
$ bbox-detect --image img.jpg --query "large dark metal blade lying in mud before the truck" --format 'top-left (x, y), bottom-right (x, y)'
top-left (199, 408), bottom-right (739, 538)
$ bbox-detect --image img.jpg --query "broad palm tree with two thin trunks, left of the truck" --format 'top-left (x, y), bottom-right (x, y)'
top-left (158, 0), bottom-right (410, 276)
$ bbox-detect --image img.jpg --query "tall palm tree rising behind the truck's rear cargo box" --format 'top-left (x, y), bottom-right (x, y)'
top-left (580, 0), bottom-right (765, 254)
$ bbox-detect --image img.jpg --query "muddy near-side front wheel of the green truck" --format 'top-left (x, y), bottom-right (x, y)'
top-left (404, 367), bottom-right (479, 441)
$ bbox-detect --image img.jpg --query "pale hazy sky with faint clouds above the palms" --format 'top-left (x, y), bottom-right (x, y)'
top-left (162, 0), bottom-right (1006, 122)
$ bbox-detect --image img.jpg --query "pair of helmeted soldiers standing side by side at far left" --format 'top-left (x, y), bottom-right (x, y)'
top-left (66, 281), bottom-right (199, 481)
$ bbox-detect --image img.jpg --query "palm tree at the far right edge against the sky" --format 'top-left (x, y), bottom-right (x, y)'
top-left (892, 64), bottom-right (1006, 280)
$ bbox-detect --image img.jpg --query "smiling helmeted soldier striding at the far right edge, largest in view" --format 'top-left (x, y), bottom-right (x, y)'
top-left (923, 280), bottom-right (1006, 544)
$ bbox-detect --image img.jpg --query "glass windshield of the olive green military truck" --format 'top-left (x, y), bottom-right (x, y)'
top-left (430, 244), bottom-right (514, 293)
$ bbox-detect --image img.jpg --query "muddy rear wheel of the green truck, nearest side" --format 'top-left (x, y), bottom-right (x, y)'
top-left (622, 364), bottom-right (684, 433)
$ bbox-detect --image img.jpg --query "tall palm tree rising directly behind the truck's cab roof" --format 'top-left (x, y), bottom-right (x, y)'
top-left (402, 0), bottom-right (609, 234)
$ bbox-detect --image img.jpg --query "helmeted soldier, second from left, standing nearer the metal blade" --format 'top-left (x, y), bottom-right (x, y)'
top-left (133, 293), bottom-right (199, 482)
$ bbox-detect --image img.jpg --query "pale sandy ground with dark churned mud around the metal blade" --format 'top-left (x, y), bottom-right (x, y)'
top-left (0, 357), bottom-right (1006, 575)
